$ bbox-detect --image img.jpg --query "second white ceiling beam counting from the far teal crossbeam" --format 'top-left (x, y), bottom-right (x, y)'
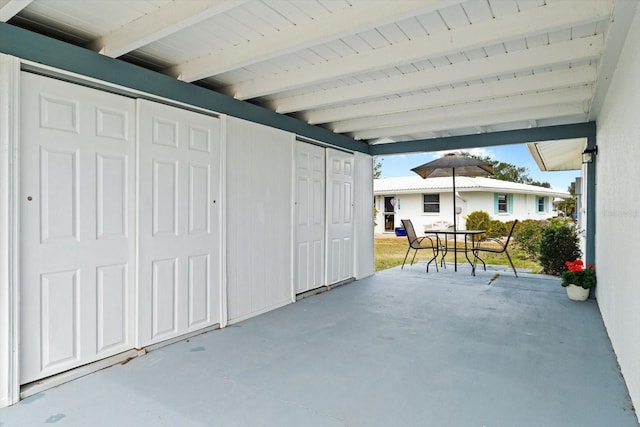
top-left (330, 85), bottom-right (593, 134)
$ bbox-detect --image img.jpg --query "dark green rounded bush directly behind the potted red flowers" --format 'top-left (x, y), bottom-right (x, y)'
top-left (539, 218), bottom-right (581, 276)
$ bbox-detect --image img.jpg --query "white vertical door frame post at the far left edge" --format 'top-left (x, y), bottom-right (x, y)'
top-left (0, 54), bottom-right (20, 407)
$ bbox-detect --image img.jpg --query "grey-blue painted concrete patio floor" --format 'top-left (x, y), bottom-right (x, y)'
top-left (0, 263), bottom-right (638, 427)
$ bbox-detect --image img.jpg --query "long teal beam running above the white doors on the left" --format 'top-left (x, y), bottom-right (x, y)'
top-left (0, 22), bottom-right (369, 153)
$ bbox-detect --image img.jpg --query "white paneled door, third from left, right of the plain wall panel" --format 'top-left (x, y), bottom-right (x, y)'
top-left (294, 141), bottom-right (326, 294)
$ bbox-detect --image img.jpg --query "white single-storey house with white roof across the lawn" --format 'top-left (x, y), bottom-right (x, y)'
top-left (373, 176), bottom-right (571, 233)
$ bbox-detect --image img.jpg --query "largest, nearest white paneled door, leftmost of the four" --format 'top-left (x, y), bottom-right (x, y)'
top-left (20, 73), bottom-right (135, 384)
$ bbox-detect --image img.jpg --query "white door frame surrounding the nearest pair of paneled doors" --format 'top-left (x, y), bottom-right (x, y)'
top-left (0, 53), bottom-right (228, 408)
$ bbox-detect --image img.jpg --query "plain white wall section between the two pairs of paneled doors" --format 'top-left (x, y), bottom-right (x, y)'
top-left (225, 118), bottom-right (294, 322)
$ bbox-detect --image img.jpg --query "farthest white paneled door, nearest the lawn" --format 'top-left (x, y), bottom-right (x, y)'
top-left (327, 148), bottom-right (354, 284)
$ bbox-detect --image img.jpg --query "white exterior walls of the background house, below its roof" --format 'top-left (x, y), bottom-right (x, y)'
top-left (375, 190), bottom-right (556, 234)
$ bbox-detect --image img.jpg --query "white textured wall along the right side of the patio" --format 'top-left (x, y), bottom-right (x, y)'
top-left (595, 8), bottom-right (640, 416)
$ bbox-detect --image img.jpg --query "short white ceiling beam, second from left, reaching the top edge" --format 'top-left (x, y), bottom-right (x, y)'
top-left (85, 0), bottom-right (247, 58)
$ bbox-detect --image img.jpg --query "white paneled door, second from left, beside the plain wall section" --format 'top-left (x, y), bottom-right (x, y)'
top-left (136, 100), bottom-right (220, 346)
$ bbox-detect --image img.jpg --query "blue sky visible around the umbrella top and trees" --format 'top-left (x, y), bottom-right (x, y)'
top-left (378, 144), bottom-right (580, 191)
